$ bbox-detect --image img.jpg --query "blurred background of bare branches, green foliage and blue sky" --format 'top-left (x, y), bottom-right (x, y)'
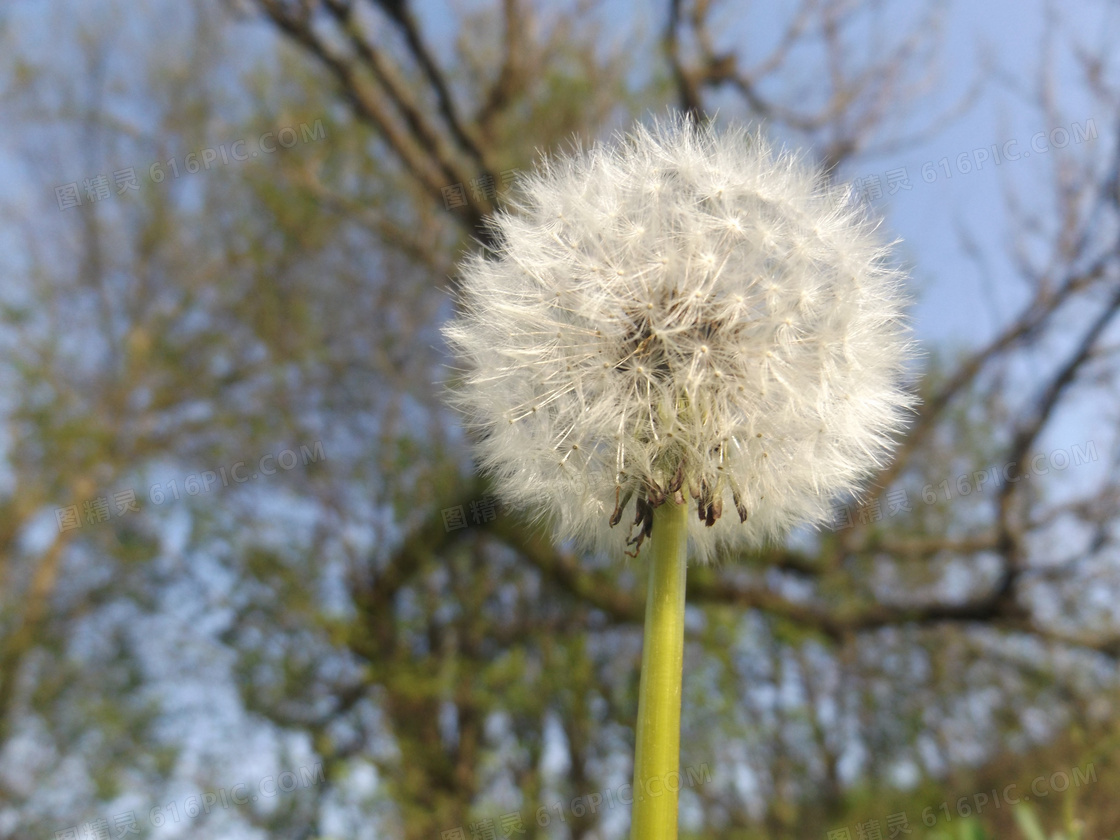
top-left (0, 0), bottom-right (1120, 840)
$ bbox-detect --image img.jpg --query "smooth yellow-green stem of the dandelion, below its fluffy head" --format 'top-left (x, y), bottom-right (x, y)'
top-left (631, 497), bottom-right (689, 840)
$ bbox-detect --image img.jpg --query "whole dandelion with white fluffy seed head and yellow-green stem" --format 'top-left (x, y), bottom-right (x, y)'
top-left (445, 118), bottom-right (914, 838)
